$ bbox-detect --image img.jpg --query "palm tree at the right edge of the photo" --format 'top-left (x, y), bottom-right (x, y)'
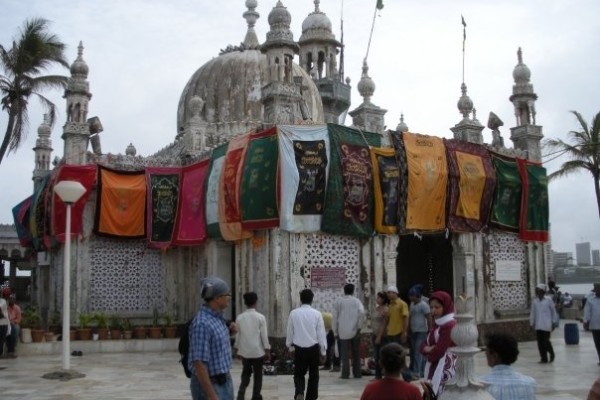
top-left (544, 111), bottom-right (600, 219)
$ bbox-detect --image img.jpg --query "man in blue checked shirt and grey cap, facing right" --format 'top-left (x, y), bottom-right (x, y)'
top-left (188, 277), bottom-right (236, 400)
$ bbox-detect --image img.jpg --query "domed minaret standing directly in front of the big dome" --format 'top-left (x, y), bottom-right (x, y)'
top-left (260, 1), bottom-right (308, 124)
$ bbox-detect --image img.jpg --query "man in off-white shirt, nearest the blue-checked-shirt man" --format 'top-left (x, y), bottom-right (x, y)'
top-left (235, 292), bottom-right (271, 400)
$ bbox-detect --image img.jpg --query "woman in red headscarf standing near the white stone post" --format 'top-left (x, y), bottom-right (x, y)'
top-left (421, 290), bottom-right (456, 395)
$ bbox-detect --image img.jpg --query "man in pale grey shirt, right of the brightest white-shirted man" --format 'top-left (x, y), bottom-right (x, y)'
top-left (333, 283), bottom-right (365, 379)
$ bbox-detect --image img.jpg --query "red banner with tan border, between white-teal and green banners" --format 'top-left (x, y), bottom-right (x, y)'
top-left (219, 133), bottom-right (252, 241)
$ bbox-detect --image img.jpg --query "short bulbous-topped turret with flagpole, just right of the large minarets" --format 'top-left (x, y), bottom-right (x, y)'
top-left (350, 59), bottom-right (387, 134)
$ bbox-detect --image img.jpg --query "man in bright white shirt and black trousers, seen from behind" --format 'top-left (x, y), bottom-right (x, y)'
top-left (285, 289), bottom-right (327, 400)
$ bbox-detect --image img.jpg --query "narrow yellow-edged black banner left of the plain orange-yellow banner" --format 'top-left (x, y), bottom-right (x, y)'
top-left (371, 147), bottom-right (400, 234)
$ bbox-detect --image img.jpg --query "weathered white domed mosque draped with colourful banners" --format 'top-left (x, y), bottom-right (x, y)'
top-left (0, 0), bottom-right (549, 344)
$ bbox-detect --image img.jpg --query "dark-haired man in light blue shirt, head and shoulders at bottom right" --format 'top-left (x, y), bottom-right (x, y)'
top-left (479, 333), bottom-right (537, 400)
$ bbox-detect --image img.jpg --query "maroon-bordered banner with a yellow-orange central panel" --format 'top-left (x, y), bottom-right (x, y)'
top-left (444, 139), bottom-right (496, 232)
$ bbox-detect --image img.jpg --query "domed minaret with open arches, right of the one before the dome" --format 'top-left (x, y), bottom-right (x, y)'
top-left (298, 0), bottom-right (351, 124)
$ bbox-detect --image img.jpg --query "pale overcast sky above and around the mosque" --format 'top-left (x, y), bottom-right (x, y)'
top-left (0, 0), bottom-right (600, 252)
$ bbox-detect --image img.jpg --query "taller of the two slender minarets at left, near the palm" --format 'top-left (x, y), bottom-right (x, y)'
top-left (62, 42), bottom-right (92, 165)
